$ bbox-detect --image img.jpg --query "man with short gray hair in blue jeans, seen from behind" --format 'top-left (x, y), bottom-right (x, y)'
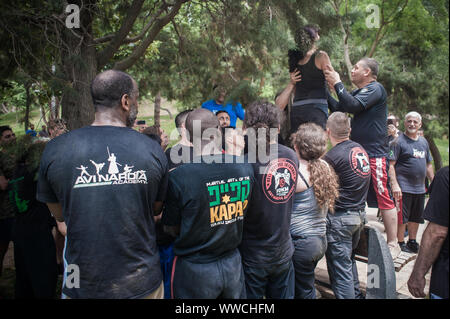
top-left (324, 112), bottom-right (370, 299)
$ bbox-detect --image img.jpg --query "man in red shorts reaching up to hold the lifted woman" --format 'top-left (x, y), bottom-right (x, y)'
top-left (325, 58), bottom-right (401, 259)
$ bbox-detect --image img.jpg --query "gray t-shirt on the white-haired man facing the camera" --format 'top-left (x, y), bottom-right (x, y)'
top-left (389, 134), bottom-right (432, 194)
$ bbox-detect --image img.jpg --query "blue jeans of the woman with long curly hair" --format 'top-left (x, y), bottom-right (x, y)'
top-left (292, 236), bottom-right (327, 299)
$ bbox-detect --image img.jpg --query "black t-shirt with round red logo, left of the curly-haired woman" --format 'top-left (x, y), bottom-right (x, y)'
top-left (239, 144), bottom-right (299, 266)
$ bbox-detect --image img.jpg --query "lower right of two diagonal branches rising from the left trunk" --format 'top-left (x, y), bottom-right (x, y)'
top-left (113, 0), bottom-right (189, 71)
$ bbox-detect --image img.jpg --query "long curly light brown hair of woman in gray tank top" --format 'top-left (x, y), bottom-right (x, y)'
top-left (292, 123), bottom-right (339, 212)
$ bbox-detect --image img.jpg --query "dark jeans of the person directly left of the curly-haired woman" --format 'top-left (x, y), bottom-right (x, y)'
top-left (242, 260), bottom-right (295, 299)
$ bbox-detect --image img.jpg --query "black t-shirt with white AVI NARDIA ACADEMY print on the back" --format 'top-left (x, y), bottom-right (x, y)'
top-left (37, 126), bottom-right (168, 298)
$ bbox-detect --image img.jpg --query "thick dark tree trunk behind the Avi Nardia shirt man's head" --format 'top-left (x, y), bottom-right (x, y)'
top-left (62, 1), bottom-right (97, 130)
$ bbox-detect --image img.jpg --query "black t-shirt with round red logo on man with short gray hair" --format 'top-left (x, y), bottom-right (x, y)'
top-left (324, 141), bottom-right (370, 211)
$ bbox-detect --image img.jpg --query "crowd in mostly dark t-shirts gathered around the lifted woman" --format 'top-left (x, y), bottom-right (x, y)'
top-left (0, 26), bottom-right (448, 299)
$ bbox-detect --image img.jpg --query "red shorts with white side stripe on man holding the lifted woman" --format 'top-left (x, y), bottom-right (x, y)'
top-left (368, 157), bottom-right (395, 210)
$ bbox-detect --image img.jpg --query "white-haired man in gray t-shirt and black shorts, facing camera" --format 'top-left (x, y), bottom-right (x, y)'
top-left (388, 112), bottom-right (434, 253)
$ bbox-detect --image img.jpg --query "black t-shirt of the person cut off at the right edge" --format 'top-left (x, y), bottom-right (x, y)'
top-left (423, 166), bottom-right (449, 299)
